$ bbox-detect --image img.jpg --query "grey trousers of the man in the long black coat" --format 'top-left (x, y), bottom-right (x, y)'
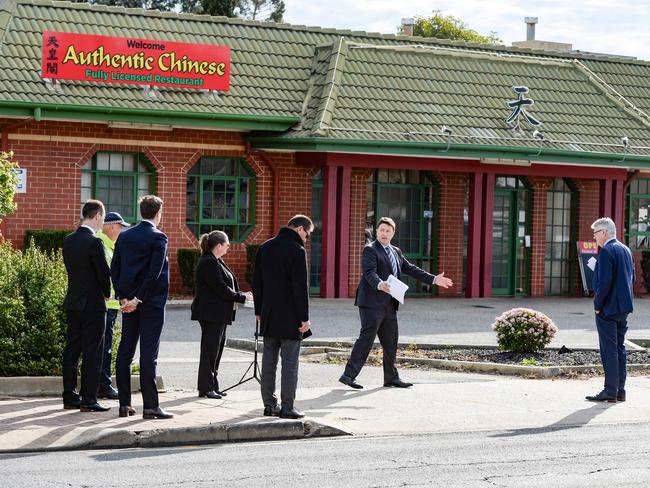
top-left (260, 336), bottom-right (301, 410)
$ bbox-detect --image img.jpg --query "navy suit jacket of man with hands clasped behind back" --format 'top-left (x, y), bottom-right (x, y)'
top-left (111, 221), bottom-right (169, 308)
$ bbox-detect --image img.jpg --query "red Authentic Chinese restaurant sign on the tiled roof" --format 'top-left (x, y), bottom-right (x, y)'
top-left (41, 31), bottom-right (230, 90)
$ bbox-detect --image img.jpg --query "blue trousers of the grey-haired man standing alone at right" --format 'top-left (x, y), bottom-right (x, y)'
top-left (596, 313), bottom-right (628, 396)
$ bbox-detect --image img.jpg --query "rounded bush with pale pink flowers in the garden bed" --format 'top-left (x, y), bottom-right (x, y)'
top-left (492, 308), bottom-right (558, 352)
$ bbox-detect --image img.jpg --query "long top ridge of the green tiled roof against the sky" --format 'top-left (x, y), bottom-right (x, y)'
top-left (22, 0), bottom-right (650, 66)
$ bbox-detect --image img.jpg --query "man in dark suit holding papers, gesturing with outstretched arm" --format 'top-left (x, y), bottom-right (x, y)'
top-left (339, 217), bottom-right (453, 389)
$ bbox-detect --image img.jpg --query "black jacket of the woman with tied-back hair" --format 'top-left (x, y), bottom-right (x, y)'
top-left (192, 254), bottom-right (246, 324)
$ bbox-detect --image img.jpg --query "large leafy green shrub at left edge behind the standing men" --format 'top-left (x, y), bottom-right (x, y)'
top-left (0, 242), bottom-right (67, 376)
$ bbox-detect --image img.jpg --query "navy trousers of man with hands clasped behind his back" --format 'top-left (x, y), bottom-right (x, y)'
top-left (115, 303), bottom-right (165, 409)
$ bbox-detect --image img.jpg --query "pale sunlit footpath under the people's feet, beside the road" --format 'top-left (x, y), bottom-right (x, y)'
top-left (0, 368), bottom-right (650, 453)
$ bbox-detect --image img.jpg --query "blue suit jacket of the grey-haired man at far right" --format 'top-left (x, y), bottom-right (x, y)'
top-left (594, 239), bottom-right (636, 317)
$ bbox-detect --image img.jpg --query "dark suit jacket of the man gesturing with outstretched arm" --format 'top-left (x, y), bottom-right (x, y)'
top-left (354, 241), bottom-right (435, 308)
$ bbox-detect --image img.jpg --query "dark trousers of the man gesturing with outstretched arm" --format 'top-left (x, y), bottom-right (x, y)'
top-left (345, 303), bottom-right (399, 383)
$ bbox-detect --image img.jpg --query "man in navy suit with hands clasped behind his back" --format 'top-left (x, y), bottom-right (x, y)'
top-left (111, 195), bottom-right (173, 419)
